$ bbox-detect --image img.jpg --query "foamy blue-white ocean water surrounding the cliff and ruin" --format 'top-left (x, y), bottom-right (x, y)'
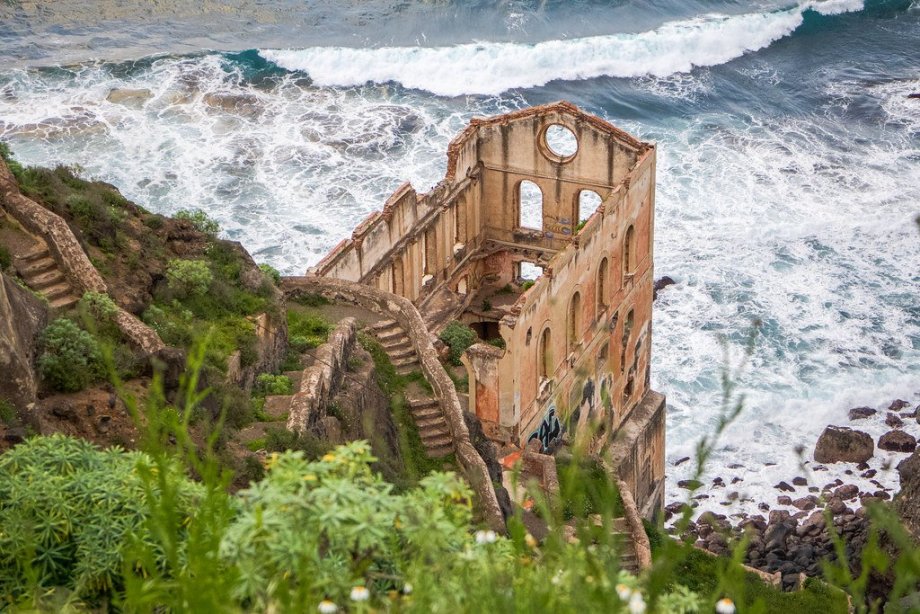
top-left (0, 0), bottom-right (920, 513)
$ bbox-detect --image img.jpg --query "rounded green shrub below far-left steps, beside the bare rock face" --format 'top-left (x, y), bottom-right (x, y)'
top-left (38, 318), bottom-right (103, 392)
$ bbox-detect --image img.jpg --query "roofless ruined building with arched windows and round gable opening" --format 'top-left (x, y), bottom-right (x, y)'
top-left (310, 102), bottom-right (665, 516)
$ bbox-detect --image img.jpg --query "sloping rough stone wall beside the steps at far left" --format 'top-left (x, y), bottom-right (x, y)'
top-left (0, 159), bottom-right (166, 356)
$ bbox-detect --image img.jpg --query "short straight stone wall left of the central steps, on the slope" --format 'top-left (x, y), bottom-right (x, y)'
top-left (287, 318), bottom-right (357, 434)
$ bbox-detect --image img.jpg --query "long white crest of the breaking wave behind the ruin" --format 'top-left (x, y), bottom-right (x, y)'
top-left (261, 0), bottom-right (862, 96)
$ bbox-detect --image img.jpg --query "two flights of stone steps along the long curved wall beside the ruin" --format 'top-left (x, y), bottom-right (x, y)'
top-left (369, 320), bottom-right (454, 458)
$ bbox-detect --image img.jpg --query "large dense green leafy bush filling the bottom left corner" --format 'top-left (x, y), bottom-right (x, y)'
top-left (0, 434), bottom-right (201, 605)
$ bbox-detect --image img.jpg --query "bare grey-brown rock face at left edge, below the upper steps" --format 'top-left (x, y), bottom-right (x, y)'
top-left (0, 273), bottom-right (48, 407)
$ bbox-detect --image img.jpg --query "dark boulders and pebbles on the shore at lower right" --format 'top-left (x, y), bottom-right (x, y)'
top-left (665, 399), bottom-right (920, 590)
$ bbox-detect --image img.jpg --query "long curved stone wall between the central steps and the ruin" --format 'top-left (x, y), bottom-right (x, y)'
top-left (281, 276), bottom-right (506, 533)
